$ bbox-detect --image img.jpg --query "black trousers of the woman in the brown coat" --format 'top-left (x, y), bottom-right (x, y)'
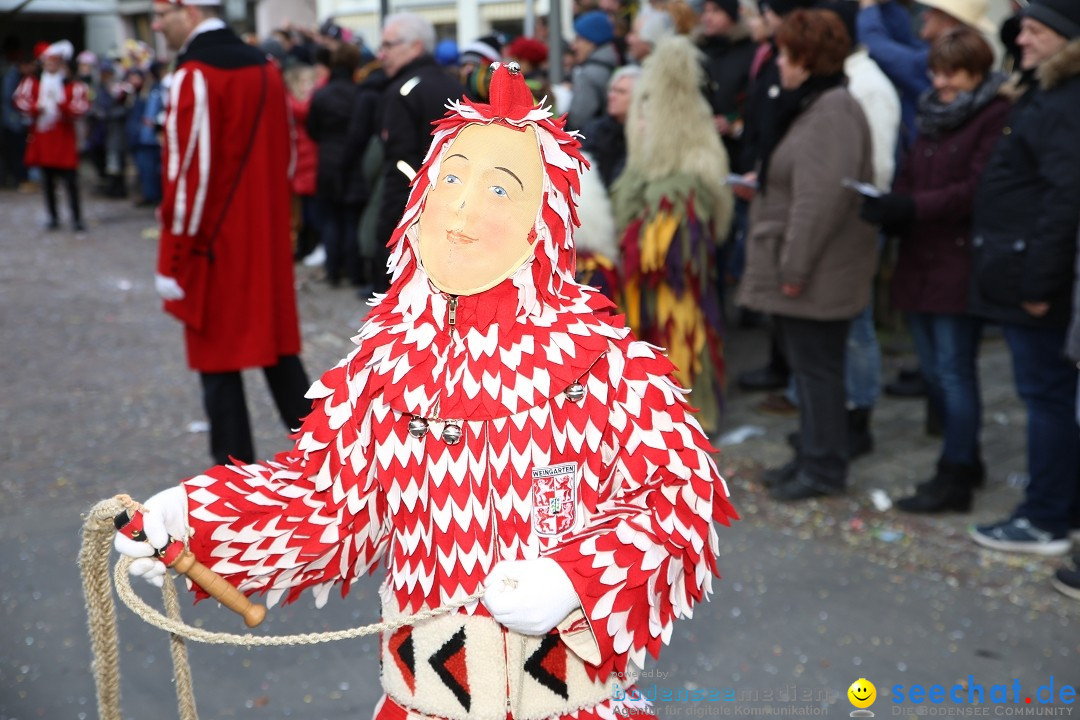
top-left (773, 315), bottom-right (851, 488)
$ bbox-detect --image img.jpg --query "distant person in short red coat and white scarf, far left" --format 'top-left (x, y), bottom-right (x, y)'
top-left (12, 40), bottom-right (90, 230)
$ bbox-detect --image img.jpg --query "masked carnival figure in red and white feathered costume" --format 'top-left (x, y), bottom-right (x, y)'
top-left (117, 65), bottom-right (735, 720)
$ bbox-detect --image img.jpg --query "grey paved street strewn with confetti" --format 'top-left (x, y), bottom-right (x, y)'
top-left (0, 185), bottom-right (1080, 720)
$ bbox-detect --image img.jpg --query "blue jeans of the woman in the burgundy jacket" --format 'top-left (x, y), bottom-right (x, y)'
top-left (907, 313), bottom-right (983, 465)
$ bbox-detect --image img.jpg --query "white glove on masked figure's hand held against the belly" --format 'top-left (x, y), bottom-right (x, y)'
top-left (481, 557), bottom-right (581, 635)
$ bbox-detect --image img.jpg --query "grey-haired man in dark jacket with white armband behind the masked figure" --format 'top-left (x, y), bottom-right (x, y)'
top-left (373, 13), bottom-right (464, 293)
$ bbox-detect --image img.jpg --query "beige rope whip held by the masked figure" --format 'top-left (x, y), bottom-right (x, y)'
top-left (79, 495), bottom-right (484, 720)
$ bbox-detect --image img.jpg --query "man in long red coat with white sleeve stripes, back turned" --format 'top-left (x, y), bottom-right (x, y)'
top-left (153, 0), bottom-right (311, 462)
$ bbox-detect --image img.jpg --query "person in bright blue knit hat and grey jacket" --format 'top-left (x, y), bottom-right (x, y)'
top-left (566, 10), bottom-right (619, 130)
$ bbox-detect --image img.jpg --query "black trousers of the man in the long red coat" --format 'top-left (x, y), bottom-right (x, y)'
top-left (199, 355), bottom-right (311, 465)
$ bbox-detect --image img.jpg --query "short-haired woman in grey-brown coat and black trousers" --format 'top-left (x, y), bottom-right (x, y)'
top-left (739, 10), bottom-right (877, 501)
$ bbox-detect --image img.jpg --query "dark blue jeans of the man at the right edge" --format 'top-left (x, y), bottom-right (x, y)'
top-left (1002, 325), bottom-right (1080, 535)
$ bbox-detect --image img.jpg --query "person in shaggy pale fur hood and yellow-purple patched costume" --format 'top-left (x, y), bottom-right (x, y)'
top-left (612, 37), bottom-right (733, 432)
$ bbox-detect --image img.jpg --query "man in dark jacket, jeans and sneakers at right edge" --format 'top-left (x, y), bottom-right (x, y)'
top-left (971, 0), bottom-right (1080, 555)
